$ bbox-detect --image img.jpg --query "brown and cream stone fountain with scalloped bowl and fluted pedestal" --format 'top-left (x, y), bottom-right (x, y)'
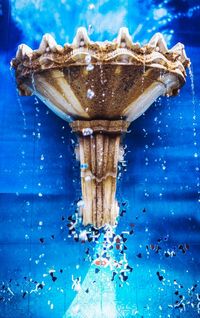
top-left (12, 28), bottom-right (190, 228)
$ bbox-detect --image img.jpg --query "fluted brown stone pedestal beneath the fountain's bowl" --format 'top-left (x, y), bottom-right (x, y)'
top-left (71, 120), bottom-right (129, 228)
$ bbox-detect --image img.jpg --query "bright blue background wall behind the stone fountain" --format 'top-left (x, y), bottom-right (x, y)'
top-left (0, 0), bottom-right (200, 318)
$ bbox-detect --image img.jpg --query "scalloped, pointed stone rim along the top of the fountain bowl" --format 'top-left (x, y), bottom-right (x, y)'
top-left (11, 27), bottom-right (190, 80)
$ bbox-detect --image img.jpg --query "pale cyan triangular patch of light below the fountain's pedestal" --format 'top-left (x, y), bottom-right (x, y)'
top-left (63, 227), bottom-right (117, 318)
